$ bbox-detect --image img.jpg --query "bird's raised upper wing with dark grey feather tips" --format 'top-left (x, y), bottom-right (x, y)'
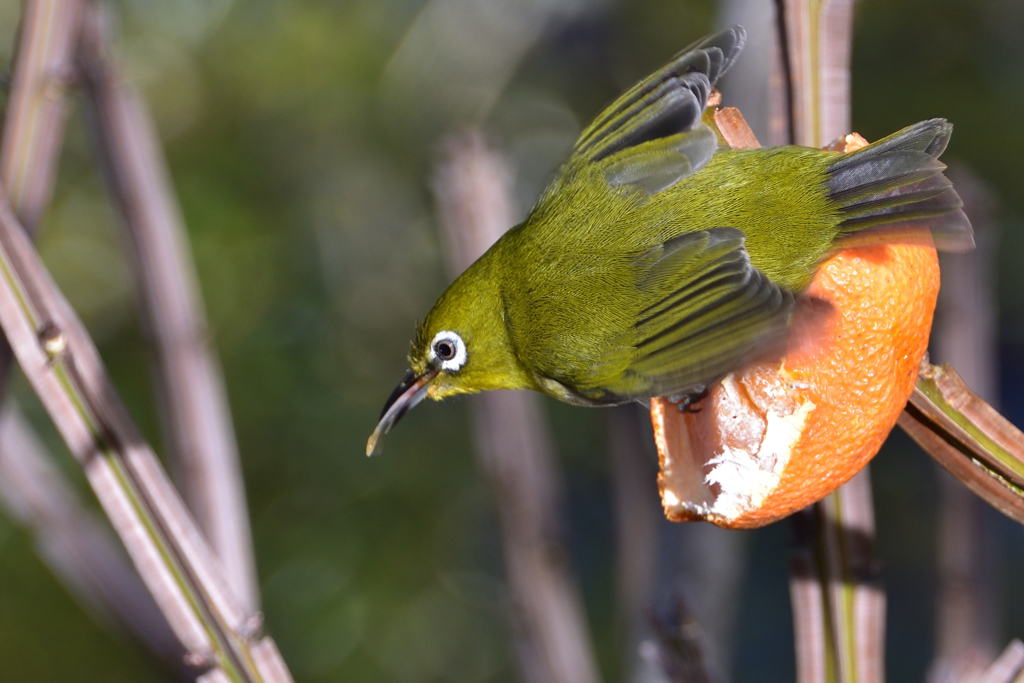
top-left (567, 27), bottom-right (746, 195)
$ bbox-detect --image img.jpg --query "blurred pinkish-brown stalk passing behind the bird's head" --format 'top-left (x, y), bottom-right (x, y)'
top-left (434, 132), bottom-right (599, 683)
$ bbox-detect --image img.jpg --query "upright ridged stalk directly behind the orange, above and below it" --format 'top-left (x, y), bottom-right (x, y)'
top-left (775, 0), bottom-right (885, 683)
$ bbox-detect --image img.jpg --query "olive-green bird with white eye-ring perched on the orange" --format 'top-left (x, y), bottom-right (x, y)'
top-left (367, 27), bottom-right (974, 455)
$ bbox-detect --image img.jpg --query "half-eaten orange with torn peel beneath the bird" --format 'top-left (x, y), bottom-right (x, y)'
top-left (651, 131), bottom-right (939, 527)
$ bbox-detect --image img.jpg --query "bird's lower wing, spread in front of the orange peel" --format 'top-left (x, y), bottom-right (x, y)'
top-left (594, 227), bottom-right (795, 398)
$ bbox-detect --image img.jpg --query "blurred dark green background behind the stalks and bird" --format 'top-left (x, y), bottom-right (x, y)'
top-left (0, 0), bottom-right (1024, 683)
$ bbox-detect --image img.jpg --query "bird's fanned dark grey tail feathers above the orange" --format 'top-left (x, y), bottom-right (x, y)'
top-left (826, 119), bottom-right (974, 252)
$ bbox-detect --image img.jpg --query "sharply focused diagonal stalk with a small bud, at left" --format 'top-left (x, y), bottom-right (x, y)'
top-left (0, 183), bottom-right (290, 681)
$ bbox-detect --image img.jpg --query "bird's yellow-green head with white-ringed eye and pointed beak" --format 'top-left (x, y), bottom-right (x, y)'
top-left (367, 261), bottom-right (534, 456)
